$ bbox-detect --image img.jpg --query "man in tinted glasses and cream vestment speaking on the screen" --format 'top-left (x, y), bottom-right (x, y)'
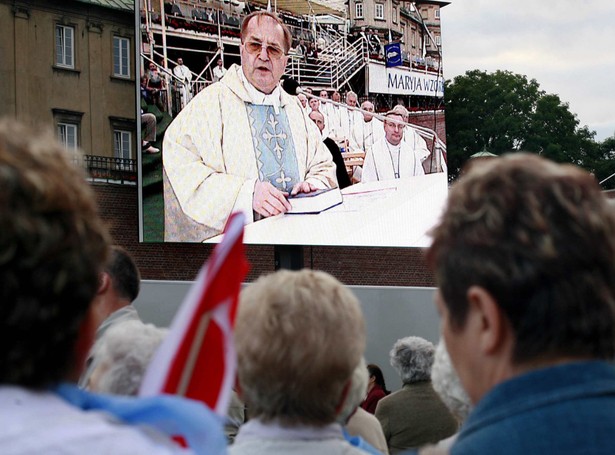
top-left (163, 11), bottom-right (338, 242)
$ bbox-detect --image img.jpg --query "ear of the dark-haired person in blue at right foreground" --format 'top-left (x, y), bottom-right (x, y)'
top-left (467, 286), bottom-right (510, 355)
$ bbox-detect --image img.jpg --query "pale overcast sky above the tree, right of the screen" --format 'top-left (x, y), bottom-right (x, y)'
top-left (441, 0), bottom-right (615, 141)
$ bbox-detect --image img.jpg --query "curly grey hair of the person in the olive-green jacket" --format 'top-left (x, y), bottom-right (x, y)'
top-left (389, 337), bottom-right (435, 384)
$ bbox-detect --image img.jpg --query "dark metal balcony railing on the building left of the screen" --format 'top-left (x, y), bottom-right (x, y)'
top-left (76, 155), bottom-right (137, 185)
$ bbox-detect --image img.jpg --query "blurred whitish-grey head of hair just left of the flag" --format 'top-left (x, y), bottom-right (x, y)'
top-left (88, 320), bottom-right (168, 395)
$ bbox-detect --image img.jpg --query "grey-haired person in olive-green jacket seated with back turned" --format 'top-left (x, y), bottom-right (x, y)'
top-left (376, 337), bottom-right (457, 454)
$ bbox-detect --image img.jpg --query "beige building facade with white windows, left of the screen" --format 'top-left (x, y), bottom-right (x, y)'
top-left (0, 0), bottom-right (138, 159)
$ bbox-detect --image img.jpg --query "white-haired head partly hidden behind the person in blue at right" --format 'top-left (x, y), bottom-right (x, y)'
top-left (431, 341), bottom-right (472, 423)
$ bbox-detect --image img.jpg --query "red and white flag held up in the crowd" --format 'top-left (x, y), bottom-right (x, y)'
top-left (139, 213), bottom-right (249, 416)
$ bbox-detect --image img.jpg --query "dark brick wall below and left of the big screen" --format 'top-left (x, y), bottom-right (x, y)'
top-left (94, 184), bottom-right (434, 286)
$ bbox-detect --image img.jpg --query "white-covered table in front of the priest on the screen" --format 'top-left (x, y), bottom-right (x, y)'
top-left (207, 173), bottom-right (448, 247)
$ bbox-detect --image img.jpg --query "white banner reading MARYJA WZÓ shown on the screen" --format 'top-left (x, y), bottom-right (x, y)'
top-left (369, 63), bottom-right (444, 98)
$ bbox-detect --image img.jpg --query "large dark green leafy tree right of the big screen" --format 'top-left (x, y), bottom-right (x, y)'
top-left (445, 70), bottom-right (600, 179)
